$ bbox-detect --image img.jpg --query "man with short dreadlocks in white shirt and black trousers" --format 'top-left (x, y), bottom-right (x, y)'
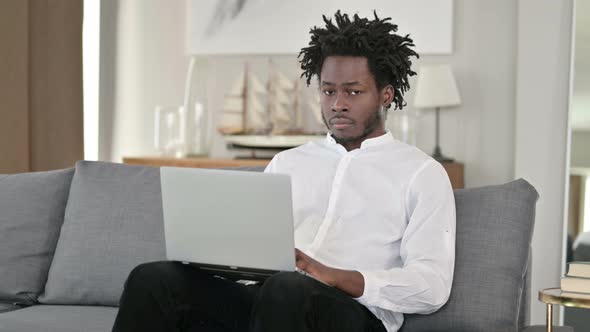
top-left (114, 12), bottom-right (455, 332)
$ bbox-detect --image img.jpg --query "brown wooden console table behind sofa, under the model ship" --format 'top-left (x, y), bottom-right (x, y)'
top-left (123, 157), bottom-right (465, 189)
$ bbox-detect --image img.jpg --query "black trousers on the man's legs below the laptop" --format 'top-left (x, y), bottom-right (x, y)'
top-left (113, 262), bottom-right (386, 332)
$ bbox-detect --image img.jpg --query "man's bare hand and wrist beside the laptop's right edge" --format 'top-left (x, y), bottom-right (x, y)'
top-left (295, 249), bottom-right (365, 297)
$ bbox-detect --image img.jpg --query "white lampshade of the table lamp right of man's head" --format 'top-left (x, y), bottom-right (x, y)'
top-left (414, 65), bottom-right (461, 108)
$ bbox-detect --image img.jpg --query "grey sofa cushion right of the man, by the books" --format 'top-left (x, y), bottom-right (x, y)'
top-left (401, 179), bottom-right (538, 332)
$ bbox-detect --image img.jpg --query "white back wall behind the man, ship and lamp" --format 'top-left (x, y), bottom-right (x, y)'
top-left (100, 0), bottom-right (516, 186)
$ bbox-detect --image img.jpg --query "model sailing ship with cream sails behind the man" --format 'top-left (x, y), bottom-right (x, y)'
top-left (218, 61), bottom-right (323, 148)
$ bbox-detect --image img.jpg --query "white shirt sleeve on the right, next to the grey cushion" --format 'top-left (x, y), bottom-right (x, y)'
top-left (357, 160), bottom-right (456, 314)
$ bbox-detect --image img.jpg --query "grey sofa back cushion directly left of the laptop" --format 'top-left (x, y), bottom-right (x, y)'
top-left (39, 161), bottom-right (165, 306)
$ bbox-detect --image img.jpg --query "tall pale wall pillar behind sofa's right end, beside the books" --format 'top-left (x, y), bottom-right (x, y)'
top-left (515, 0), bottom-right (573, 324)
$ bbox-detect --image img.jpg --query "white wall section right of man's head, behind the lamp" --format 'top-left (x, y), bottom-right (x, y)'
top-left (408, 0), bottom-right (516, 187)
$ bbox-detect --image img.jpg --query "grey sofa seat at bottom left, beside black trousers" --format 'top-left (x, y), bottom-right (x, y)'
top-left (0, 305), bottom-right (118, 332)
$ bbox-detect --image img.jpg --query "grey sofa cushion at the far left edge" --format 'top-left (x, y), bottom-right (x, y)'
top-left (0, 168), bottom-right (74, 304)
